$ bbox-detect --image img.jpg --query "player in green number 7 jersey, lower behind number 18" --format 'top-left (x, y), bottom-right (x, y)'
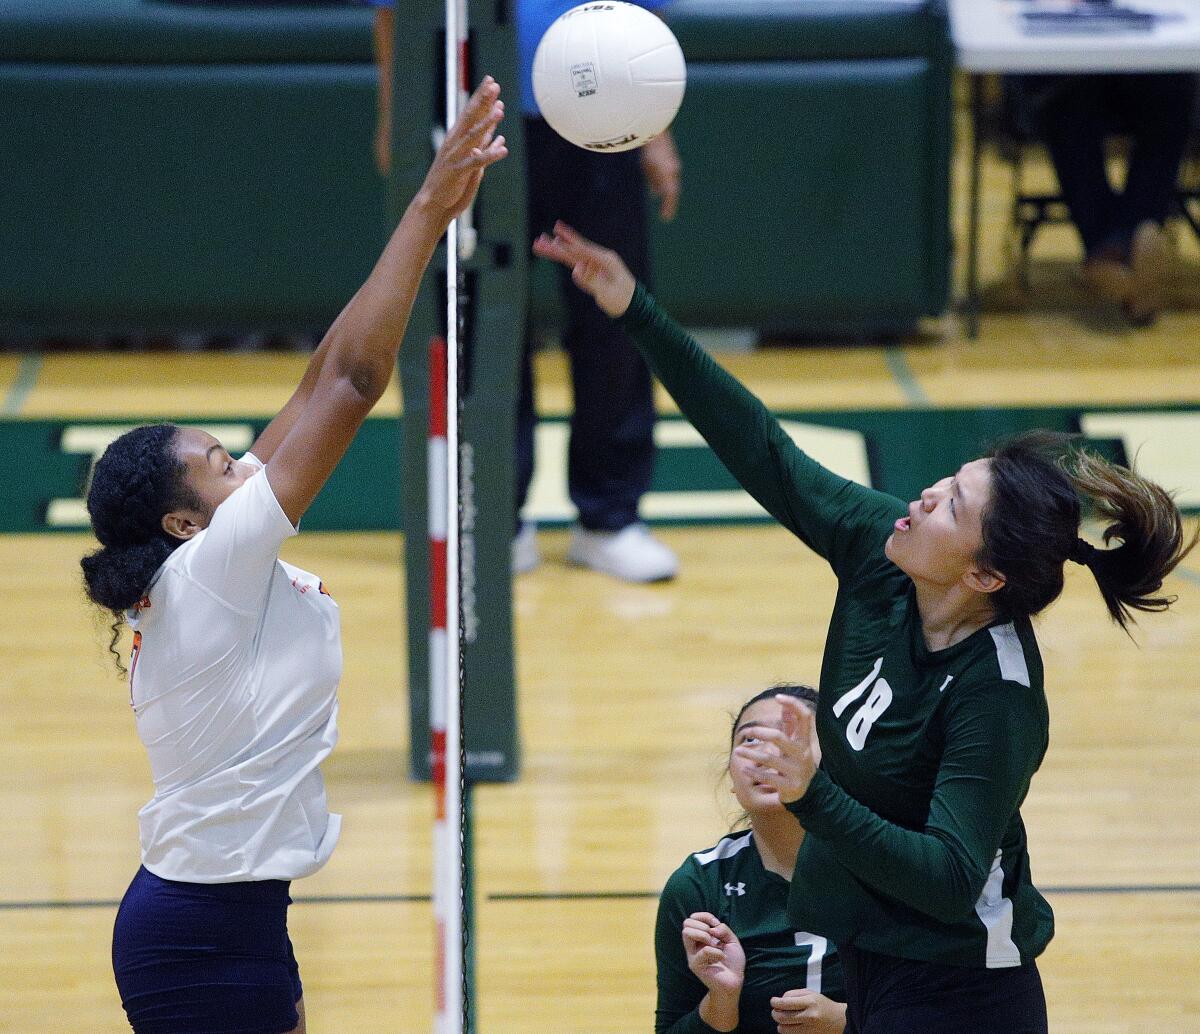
top-left (654, 685), bottom-right (846, 1034)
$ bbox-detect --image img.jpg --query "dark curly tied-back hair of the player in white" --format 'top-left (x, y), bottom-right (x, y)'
top-left (79, 423), bottom-right (200, 673)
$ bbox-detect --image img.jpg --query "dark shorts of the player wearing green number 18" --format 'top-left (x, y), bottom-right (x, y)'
top-left (838, 946), bottom-right (1046, 1034)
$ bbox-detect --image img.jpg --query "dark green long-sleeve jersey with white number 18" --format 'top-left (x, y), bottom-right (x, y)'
top-left (622, 285), bottom-right (1054, 968)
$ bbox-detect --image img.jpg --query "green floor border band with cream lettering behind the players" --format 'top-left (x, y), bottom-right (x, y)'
top-left (0, 404), bottom-right (1200, 533)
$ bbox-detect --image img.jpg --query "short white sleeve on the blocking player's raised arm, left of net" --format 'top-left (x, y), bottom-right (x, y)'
top-left (181, 452), bottom-right (298, 614)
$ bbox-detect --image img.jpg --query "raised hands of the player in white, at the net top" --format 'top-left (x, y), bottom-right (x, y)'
top-left (418, 76), bottom-right (509, 226)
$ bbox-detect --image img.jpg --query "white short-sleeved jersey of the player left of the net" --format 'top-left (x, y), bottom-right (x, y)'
top-left (127, 455), bottom-right (342, 883)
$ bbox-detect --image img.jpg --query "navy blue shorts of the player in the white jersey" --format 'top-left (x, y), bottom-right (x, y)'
top-left (113, 868), bottom-right (302, 1034)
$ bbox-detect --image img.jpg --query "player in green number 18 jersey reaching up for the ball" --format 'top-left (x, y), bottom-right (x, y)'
top-left (534, 223), bottom-right (1195, 1034)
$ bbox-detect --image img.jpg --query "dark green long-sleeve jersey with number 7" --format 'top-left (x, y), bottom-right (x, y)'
top-left (654, 830), bottom-right (846, 1034)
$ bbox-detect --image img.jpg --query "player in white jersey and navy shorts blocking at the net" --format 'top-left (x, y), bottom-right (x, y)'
top-left (75, 77), bottom-right (506, 1034)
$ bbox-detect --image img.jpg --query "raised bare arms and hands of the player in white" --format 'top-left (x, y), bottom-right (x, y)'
top-left (254, 76), bottom-right (508, 524)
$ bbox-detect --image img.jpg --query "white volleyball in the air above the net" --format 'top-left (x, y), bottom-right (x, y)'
top-left (533, 0), bottom-right (688, 152)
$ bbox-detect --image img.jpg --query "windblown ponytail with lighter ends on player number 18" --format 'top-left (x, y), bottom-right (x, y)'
top-left (1068, 452), bottom-right (1200, 631)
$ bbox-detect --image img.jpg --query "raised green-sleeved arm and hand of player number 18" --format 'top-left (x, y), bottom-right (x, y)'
top-left (533, 223), bottom-right (905, 573)
